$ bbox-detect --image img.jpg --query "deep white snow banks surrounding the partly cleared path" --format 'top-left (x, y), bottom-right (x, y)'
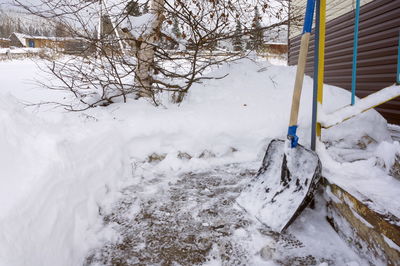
top-left (0, 57), bottom-right (400, 265)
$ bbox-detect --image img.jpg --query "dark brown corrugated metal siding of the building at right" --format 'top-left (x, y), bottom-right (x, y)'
top-left (288, 0), bottom-right (400, 124)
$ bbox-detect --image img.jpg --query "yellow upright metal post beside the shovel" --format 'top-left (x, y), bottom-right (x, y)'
top-left (317, 0), bottom-right (326, 139)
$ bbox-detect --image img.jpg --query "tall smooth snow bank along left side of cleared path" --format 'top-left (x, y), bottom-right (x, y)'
top-left (0, 97), bottom-right (127, 265)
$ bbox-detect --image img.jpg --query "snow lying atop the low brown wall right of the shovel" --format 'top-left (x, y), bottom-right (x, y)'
top-left (318, 137), bottom-right (400, 217)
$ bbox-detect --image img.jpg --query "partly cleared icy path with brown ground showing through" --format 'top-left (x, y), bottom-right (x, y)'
top-left (86, 164), bottom-right (365, 265)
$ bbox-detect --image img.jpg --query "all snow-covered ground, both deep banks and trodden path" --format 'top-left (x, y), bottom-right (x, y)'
top-left (0, 59), bottom-right (400, 266)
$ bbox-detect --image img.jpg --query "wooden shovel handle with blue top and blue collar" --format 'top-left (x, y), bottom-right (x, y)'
top-left (288, 0), bottom-right (315, 148)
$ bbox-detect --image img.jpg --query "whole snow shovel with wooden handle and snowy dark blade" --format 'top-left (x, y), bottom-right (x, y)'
top-left (236, 0), bottom-right (321, 233)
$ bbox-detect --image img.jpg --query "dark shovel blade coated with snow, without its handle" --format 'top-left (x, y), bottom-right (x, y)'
top-left (236, 139), bottom-right (321, 232)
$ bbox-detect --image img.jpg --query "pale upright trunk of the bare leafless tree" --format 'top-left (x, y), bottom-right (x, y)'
top-left (135, 0), bottom-right (165, 98)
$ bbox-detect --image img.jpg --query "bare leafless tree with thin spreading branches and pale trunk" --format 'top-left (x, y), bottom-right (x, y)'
top-left (16, 0), bottom-right (288, 110)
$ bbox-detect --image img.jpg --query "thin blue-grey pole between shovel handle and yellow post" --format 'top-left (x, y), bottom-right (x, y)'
top-left (311, 0), bottom-right (321, 151)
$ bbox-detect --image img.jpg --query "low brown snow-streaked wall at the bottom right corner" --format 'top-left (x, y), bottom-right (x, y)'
top-left (324, 179), bottom-right (400, 265)
